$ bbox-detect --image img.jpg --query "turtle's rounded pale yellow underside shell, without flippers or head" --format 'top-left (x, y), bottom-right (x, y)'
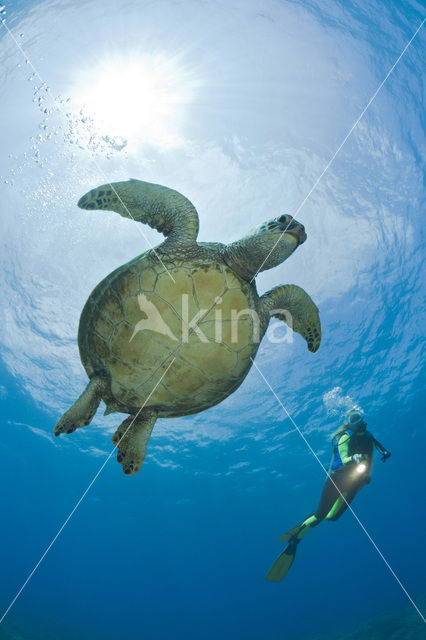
top-left (79, 252), bottom-right (263, 417)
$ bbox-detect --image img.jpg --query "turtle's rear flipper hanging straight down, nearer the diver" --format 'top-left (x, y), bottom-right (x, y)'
top-left (112, 408), bottom-right (157, 475)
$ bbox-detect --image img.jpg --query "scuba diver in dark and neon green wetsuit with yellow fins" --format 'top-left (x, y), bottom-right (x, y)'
top-left (266, 408), bottom-right (391, 582)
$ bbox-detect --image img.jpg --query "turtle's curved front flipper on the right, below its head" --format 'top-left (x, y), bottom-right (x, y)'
top-left (261, 284), bottom-right (321, 353)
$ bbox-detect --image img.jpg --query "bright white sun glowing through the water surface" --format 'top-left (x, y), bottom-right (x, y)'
top-left (74, 56), bottom-right (193, 146)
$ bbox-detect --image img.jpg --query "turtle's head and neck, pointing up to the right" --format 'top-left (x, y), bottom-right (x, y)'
top-left (225, 214), bottom-right (307, 280)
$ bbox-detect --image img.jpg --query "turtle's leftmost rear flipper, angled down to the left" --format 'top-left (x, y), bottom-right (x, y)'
top-left (53, 373), bottom-right (109, 436)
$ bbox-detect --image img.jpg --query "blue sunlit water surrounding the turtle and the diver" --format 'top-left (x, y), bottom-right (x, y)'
top-left (0, 0), bottom-right (426, 640)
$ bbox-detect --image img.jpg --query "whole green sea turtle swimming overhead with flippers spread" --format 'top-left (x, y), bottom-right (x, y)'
top-left (54, 180), bottom-right (321, 474)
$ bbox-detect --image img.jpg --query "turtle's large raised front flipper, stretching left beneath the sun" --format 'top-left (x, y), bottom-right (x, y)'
top-left (78, 179), bottom-right (199, 246)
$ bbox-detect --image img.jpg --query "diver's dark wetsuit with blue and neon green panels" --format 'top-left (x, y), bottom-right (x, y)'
top-left (294, 428), bottom-right (374, 540)
